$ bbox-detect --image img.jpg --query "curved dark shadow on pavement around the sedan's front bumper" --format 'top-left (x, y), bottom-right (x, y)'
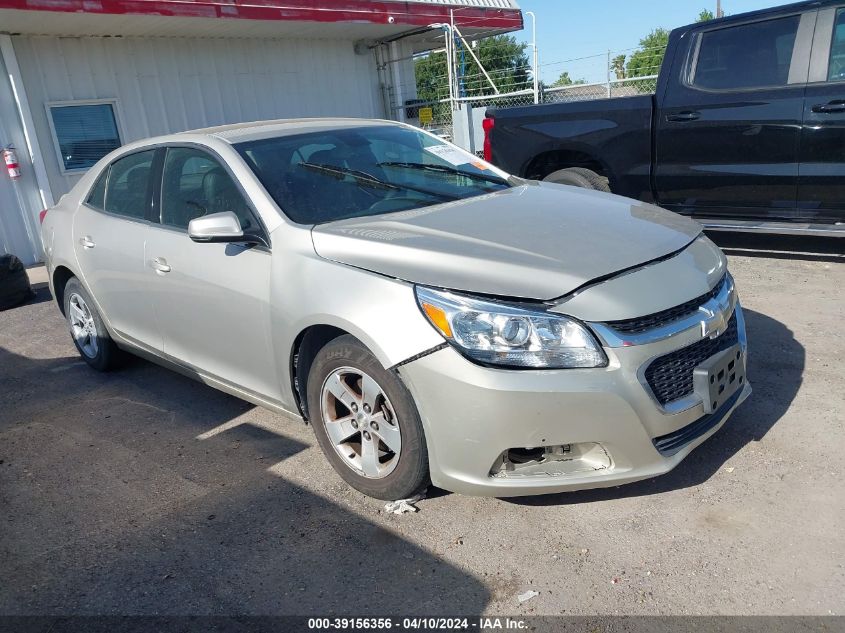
top-left (503, 309), bottom-right (806, 506)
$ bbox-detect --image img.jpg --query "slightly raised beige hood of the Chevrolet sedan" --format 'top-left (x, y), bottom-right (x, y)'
top-left (312, 182), bottom-right (701, 300)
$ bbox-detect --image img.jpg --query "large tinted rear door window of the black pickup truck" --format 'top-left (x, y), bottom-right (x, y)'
top-left (692, 15), bottom-right (801, 90)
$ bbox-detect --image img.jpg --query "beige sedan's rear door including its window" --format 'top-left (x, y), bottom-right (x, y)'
top-left (73, 150), bottom-right (161, 350)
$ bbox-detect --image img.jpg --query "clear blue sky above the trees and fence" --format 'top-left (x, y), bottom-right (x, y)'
top-left (515, 0), bottom-right (785, 83)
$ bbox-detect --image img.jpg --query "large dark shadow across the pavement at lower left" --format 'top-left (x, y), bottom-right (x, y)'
top-left (0, 347), bottom-right (491, 616)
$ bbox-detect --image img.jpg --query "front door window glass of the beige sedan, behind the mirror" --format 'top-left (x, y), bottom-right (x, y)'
top-left (161, 147), bottom-right (257, 231)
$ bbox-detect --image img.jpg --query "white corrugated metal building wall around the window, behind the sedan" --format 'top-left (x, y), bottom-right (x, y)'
top-left (13, 36), bottom-right (385, 199)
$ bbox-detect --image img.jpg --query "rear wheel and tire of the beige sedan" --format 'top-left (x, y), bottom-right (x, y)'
top-left (64, 277), bottom-right (120, 371)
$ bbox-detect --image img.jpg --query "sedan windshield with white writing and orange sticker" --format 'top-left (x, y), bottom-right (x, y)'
top-left (235, 125), bottom-right (510, 224)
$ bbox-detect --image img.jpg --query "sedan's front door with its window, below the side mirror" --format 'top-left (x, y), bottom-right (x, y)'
top-left (145, 147), bottom-right (281, 399)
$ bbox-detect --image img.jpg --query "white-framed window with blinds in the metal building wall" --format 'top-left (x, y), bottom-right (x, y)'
top-left (47, 101), bottom-right (121, 172)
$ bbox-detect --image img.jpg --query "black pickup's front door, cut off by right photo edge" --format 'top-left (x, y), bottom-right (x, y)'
top-left (798, 6), bottom-right (845, 222)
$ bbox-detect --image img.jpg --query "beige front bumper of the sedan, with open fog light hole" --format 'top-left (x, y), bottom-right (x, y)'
top-left (399, 304), bottom-right (751, 497)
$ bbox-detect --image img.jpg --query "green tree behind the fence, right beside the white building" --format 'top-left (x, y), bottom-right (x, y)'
top-left (415, 35), bottom-right (532, 101)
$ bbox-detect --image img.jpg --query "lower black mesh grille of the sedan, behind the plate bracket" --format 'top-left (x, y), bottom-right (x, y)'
top-left (645, 312), bottom-right (739, 405)
